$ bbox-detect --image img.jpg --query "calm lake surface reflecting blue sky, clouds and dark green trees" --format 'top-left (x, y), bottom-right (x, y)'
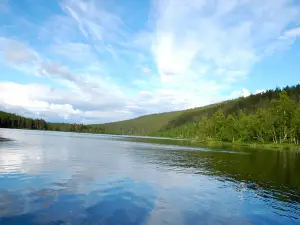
top-left (0, 129), bottom-right (300, 225)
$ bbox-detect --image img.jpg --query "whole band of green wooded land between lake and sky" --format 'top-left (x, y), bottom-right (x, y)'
top-left (0, 85), bottom-right (300, 148)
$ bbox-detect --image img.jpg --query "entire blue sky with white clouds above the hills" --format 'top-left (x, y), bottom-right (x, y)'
top-left (0, 0), bottom-right (300, 124)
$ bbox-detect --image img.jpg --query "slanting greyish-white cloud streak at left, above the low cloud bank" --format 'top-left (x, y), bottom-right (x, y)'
top-left (0, 38), bottom-right (120, 98)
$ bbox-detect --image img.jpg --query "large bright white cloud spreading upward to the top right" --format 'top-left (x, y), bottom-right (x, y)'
top-left (152, 0), bottom-right (299, 80)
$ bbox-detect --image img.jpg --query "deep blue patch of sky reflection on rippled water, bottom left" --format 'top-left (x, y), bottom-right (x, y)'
top-left (0, 179), bottom-right (155, 224)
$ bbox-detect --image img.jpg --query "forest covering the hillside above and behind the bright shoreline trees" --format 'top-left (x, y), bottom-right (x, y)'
top-left (101, 85), bottom-right (300, 138)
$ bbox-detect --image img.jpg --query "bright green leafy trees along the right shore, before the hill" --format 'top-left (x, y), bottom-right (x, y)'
top-left (153, 91), bottom-right (300, 144)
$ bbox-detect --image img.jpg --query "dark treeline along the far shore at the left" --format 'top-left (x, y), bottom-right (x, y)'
top-left (0, 111), bottom-right (105, 134)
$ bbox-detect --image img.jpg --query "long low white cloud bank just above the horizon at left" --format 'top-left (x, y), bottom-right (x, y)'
top-left (0, 79), bottom-right (210, 123)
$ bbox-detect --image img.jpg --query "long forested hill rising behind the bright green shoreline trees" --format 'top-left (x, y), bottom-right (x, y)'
top-left (98, 85), bottom-right (300, 136)
